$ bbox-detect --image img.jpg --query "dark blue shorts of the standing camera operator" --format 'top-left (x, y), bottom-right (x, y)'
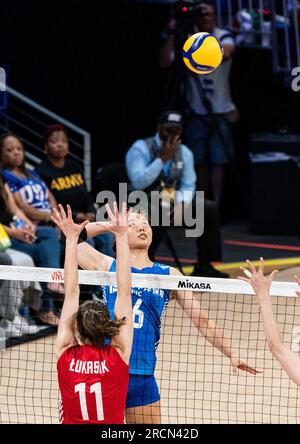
top-left (184, 114), bottom-right (234, 165)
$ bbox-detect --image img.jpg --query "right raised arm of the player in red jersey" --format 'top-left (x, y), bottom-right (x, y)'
top-left (109, 203), bottom-right (133, 363)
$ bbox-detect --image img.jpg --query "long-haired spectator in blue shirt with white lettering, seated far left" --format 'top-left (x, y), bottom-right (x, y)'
top-left (0, 134), bottom-right (57, 222)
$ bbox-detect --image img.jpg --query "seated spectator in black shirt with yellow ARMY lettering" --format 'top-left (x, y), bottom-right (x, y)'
top-left (36, 124), bottom-right (114, 256)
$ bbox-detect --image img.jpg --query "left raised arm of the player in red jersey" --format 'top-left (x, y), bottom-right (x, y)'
top-left (52, 205), bottom-right (88, 359)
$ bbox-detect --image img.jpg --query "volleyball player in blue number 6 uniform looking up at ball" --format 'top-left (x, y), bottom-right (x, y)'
top-left (78, 208), bottom-right (257, 424)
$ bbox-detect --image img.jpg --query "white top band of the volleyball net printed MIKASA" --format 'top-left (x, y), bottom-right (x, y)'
top-left (0, 265), bottom-right (299, 297)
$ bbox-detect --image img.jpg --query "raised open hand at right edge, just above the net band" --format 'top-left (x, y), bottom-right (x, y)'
top-left (238, 257), bottom-right (278, 298)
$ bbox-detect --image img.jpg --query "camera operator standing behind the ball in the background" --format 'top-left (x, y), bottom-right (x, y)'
top-left (160, 0), bottom-right (238, 204)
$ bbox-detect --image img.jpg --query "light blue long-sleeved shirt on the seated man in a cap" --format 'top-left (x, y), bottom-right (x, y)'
top-left (126, 134), bottom-right (196, 203)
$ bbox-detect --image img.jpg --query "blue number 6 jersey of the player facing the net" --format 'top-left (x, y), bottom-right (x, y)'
top-left (103, 260), bottom-right (170, 375)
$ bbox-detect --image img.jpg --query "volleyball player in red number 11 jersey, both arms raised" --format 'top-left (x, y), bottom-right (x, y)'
top-left (52, 202), bottom-right (133, 424)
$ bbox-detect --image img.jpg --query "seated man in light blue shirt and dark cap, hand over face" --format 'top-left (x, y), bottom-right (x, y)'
top-left (126, 111), bottom-right (228, 277)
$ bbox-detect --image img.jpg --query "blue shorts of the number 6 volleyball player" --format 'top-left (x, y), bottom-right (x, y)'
top-left (126, 375), bottom-right (160, 407)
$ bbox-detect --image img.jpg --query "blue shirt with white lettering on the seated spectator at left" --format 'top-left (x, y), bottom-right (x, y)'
top-left (2, 170), bottom-right (51, 212)
